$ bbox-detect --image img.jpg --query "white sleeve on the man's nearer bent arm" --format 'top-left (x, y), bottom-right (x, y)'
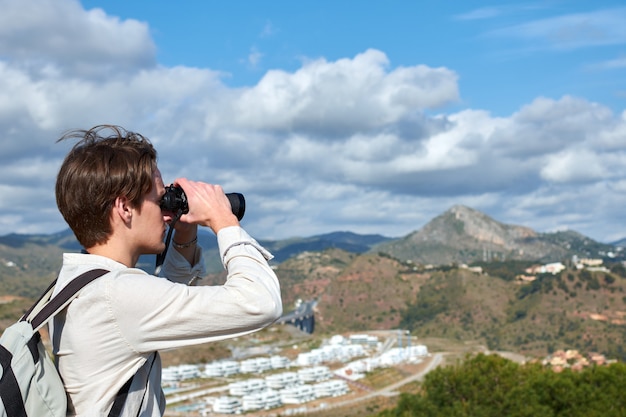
top-left (107, 226), bottom-right (282, 352)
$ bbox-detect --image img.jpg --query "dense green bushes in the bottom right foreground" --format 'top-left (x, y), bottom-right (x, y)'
top-left (378, 354), bottom-right (626, 417)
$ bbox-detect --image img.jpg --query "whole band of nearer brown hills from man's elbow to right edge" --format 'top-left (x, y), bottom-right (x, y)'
top-left (260, 250), bottom-right (626, 359)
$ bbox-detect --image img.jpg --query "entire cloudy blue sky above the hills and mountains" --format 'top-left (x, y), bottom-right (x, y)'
top-left (0, 0), bottom-right (626, 243)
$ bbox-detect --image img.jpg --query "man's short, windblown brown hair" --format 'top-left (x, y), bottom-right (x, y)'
top-left (56, 125), bottom-right (157, 248)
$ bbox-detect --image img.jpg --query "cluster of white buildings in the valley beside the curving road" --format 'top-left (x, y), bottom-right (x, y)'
top-left (162, 331), bottom-right (429, 416)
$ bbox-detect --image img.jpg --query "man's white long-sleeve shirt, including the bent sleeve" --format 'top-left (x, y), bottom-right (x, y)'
top-left (51, 227), bottom-right (282, 417)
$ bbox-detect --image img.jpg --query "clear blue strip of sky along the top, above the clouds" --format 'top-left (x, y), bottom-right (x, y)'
top-left (82, 0), bottom-right (626, 115)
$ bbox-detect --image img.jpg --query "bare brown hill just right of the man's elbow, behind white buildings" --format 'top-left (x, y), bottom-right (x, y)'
top-left (276, 249), bottom-right (427, 332)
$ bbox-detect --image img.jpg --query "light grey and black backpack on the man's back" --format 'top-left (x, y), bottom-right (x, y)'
top-left (0, 269), bottom-right (109, 417)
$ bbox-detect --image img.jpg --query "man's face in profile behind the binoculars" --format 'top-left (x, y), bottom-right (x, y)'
top-left (133, 168), bottom-right (167, 254)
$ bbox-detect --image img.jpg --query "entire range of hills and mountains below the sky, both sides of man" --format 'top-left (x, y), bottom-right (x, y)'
top-left (0, 206), bottom-right (626, 358)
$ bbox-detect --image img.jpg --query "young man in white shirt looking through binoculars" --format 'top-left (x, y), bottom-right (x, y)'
top-left (51, 126), bottom-right (282, 417)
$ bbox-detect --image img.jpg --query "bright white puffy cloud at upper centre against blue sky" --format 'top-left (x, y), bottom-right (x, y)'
top-left (233, 50), bottom-right (458, 135)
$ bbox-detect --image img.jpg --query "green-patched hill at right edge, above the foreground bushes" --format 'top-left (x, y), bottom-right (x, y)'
top-left (400, 262), bottom-right (626, 360)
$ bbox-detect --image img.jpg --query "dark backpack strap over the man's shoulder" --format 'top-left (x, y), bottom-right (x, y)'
top-left (21, 269), bottom-right (109, 331)
